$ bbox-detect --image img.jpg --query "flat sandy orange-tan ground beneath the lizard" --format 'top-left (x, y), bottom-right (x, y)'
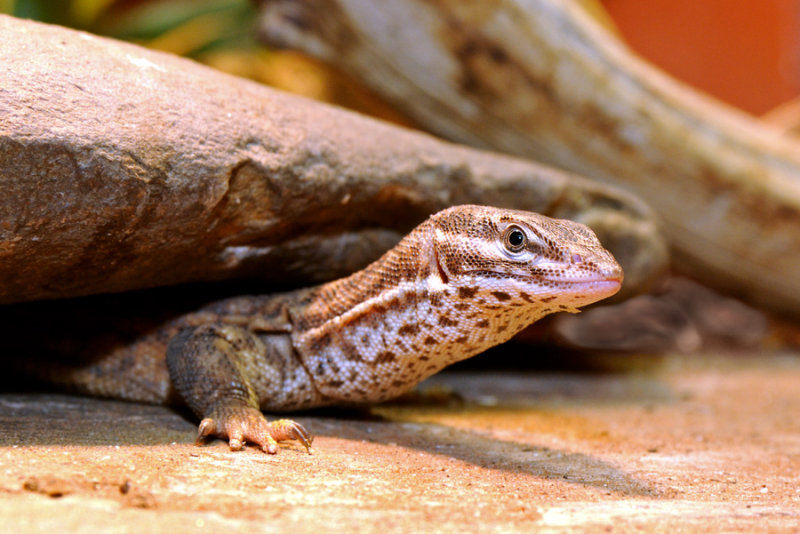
top-left (0, 354), bottom-right (800, 534)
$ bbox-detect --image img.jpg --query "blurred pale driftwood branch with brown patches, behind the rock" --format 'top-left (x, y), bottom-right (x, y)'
top-left (261, 0), bottom-right (800, 317)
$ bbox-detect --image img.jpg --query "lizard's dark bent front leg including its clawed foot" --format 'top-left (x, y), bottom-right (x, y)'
top-left (167, 324), bottom-right (311, 454)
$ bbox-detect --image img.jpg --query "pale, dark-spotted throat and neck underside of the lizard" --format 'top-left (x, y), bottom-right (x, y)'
top-left (294, 272), bottom-right (596, 402)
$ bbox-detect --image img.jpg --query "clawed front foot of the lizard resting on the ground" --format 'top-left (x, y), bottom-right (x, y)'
top-left (197, 406), bottom-right (313, 454)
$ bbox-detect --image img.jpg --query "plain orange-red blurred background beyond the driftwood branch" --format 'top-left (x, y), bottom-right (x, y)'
top-left (602, 0), bottom-right (800, 115)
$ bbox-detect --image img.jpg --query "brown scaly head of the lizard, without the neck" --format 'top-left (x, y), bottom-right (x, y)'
top-left (430, 206), bottom-right (623, 314)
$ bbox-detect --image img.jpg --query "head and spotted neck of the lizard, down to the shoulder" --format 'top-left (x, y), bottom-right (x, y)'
top-left (291, 206), bottom-right (622, 400)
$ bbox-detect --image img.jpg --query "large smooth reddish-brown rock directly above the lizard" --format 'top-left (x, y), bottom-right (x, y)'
top-left (0, 16), bottom-right (666, 303)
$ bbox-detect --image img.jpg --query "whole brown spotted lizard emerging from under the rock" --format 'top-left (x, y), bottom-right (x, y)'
top-left (21, 205), bottom-right (623, 454)
